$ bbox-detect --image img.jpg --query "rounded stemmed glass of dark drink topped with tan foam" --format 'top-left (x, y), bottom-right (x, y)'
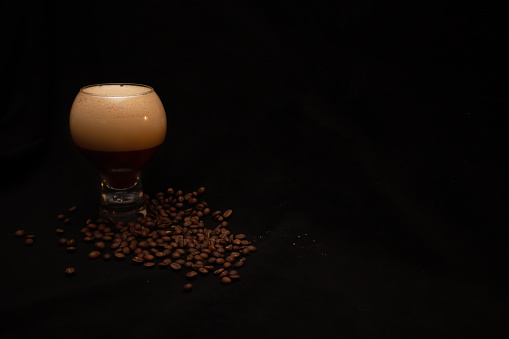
top-left (69, 83), bottom-right (166, 218)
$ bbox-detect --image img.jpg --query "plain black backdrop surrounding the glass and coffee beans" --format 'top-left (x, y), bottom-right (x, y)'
top-left (0, 1), bottom-right (509, 338)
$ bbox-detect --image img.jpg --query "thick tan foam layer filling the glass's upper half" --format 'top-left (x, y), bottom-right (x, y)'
top-left (69, 84), bottom-right (166, 152)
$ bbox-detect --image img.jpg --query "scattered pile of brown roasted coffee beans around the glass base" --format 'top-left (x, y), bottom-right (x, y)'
top-left (51, 187), bottom-right (256, 292)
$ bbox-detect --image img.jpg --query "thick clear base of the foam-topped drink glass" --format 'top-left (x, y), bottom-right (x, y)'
top-left (100, 175), bottom-right (146, 221)
